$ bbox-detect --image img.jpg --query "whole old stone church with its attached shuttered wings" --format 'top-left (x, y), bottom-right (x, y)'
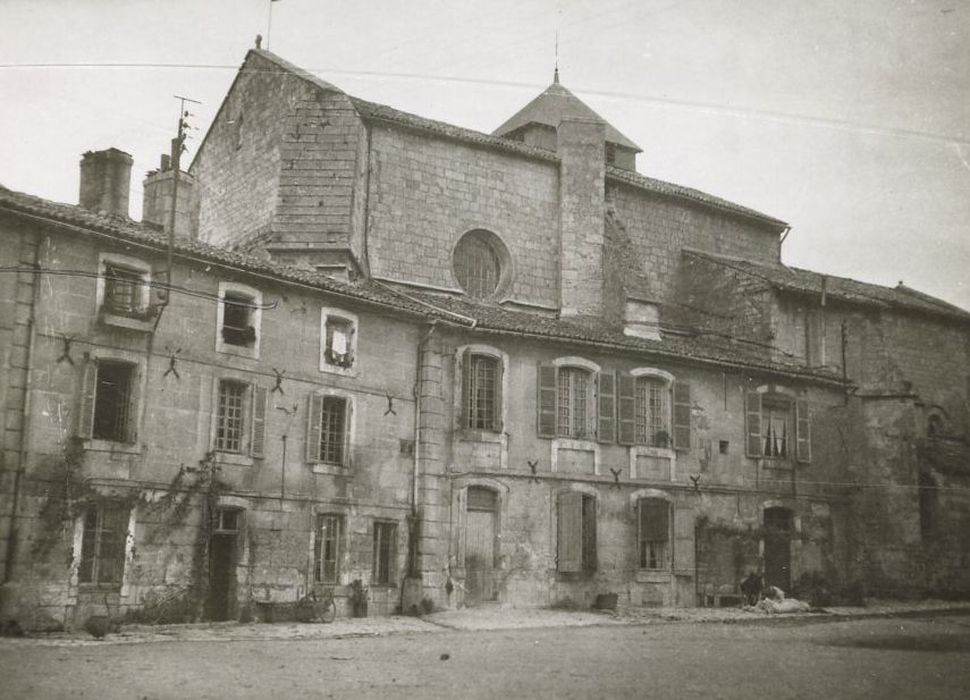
top-left (0, 48), bottom-right (970, 626)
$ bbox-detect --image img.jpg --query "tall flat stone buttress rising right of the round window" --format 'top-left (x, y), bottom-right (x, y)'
top-left (556, 117), bottom-right (606, 316)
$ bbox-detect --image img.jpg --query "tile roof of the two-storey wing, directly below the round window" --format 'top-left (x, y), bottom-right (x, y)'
top-left (409, 292), bottom-right (842, 385)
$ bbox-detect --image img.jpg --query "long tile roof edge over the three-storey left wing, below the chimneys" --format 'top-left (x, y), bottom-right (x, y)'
top-left (0, 186), bottom-right (428, 316)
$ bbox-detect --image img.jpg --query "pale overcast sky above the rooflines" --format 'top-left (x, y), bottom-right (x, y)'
top-left (0, 0), bottom-right (970, 309)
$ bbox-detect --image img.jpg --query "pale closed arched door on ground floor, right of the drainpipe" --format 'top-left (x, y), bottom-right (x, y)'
top-left (465, 486), bottom-right (498, 605)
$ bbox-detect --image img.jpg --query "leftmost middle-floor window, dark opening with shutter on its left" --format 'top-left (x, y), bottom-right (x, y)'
top-left (78, 359), bottom-right (135, 442)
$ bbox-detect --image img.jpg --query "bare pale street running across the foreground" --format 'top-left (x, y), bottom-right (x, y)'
top-left (0, 615), bottom-right (970, 700)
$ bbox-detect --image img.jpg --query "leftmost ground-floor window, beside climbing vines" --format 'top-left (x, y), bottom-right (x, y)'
top-left (78, 504), bottom-right (128, 584)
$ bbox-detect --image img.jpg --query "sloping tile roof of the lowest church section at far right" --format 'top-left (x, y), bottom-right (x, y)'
top-left (684, 250), bottom-right (970, 322)
